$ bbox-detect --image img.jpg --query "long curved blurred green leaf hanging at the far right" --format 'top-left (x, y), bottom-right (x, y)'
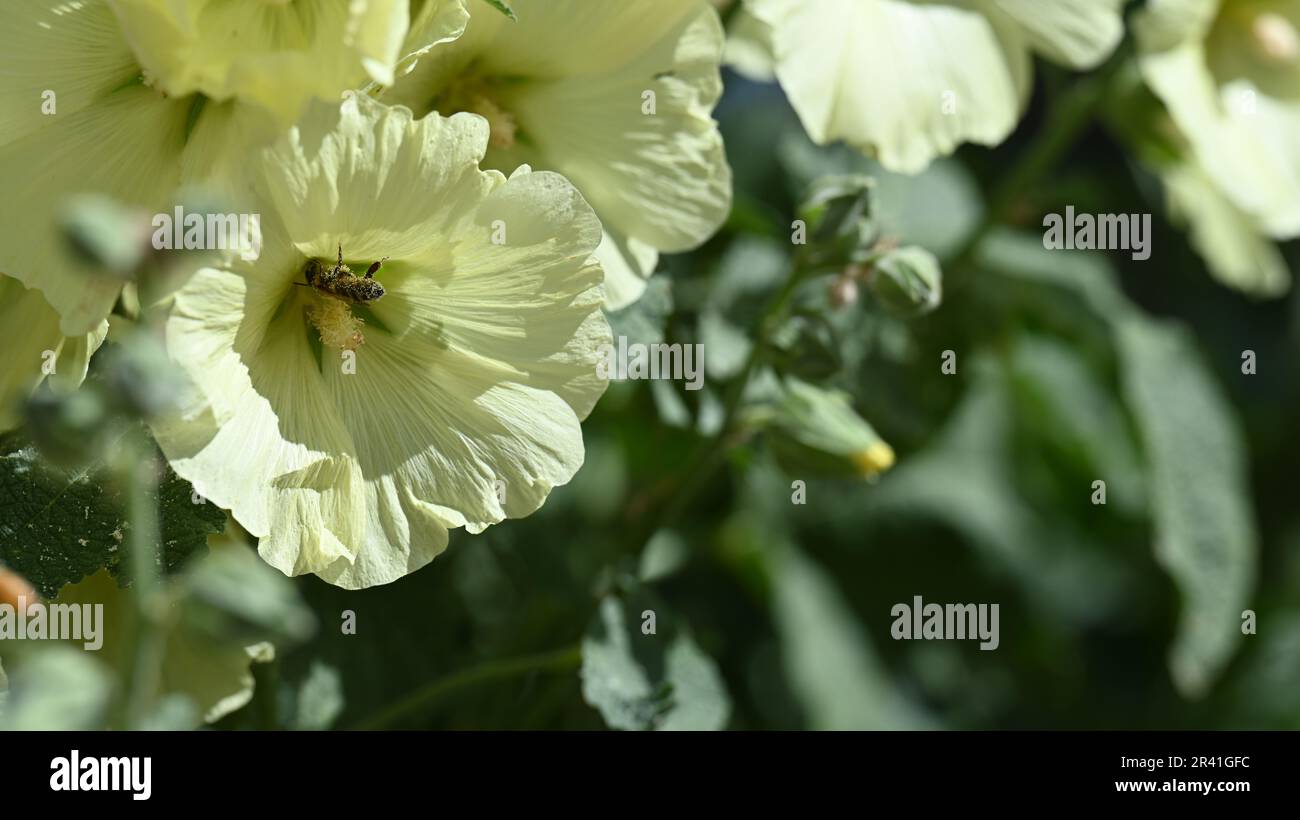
top-left (980, 234), bottom-right (1257, 697)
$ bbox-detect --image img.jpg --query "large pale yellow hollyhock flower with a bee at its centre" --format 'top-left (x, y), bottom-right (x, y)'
top-left (156, 97), bottom-right (611, 589)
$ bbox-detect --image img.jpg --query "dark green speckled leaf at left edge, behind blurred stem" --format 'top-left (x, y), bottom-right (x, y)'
top-left (0, 446), bottom-right (226, 598)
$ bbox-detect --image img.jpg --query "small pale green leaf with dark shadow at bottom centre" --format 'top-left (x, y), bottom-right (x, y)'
top-left (581, 594), bottom-right (731, 730)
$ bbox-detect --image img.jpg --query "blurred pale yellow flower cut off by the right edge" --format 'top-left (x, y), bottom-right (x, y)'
top-left (1135, 0), bottom-right (1300, 295)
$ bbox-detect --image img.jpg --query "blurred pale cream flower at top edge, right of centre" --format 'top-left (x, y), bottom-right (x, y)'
top-left (748, 0), bottom-right (1123, 173)
